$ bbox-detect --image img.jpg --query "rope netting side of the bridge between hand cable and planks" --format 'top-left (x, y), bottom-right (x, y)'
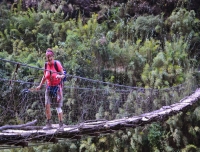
top-left (0, 59), bottom-right (197, 126)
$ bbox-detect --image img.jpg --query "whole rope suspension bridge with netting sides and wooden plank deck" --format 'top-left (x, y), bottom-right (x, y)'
top-left (0, 58), bottom-right (200, 147)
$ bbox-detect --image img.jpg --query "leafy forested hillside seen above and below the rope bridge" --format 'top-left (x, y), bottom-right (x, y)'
top-left (0, 0), bottom-right (200, 152)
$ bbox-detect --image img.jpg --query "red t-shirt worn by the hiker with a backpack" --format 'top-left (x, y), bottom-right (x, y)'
top-left (44, 61), bottom-right (63, 86)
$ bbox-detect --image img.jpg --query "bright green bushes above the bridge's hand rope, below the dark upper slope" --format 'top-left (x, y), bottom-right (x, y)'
top-left (0, 0), bottom-right (199, 88)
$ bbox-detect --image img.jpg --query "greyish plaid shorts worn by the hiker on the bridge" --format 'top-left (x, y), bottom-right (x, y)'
top-left (45, 85), bottom-right (63, 108)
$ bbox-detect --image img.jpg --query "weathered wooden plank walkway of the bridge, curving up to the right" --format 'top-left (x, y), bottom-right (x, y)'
top-left (0, 89), bottom-right (200, 147)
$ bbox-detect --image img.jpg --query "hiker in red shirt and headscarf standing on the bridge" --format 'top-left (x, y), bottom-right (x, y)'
top-left (36, 48), bottom-right (65, 130)
